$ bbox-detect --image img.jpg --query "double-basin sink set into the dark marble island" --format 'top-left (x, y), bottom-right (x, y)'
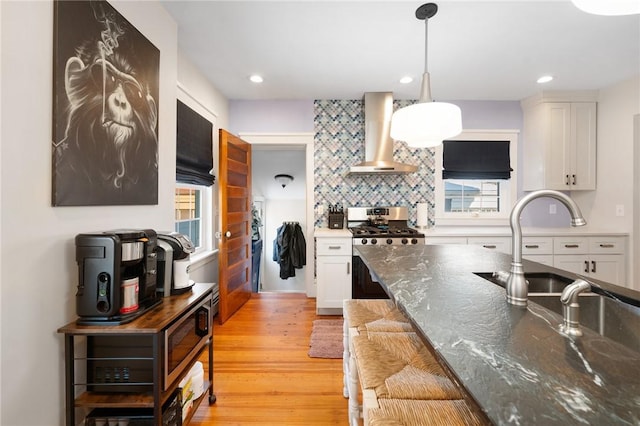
top-left (476, 272), bottom-right (640, 352)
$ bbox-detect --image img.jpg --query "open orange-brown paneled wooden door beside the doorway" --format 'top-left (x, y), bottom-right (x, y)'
top-left (218, 129), bottom-right (251, 324)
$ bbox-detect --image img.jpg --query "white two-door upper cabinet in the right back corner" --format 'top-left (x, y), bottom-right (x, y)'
top-left (521, 91), bottom-right (597, 191)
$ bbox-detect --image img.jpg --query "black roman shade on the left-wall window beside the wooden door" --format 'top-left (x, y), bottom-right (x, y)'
top-left (176, 101), bottom-right (215, 186)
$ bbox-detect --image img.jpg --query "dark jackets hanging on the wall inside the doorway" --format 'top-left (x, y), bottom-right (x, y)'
top-left (273, 222), bottom-right (307, 280)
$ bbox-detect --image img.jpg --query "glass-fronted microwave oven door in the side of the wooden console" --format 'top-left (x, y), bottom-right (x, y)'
top-left (164, 295), bottom-right (213, 390)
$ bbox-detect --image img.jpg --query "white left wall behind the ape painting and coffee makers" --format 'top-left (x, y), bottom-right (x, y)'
top-left (0, 1), bottom-right (228, 425)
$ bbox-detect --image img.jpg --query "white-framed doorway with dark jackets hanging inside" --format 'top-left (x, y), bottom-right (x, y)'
top-left (240, 133), bottom-right (316, 297)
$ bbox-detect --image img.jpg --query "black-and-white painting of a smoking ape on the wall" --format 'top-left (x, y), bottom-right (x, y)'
top-left (52, 0), bottom-right (160, 206)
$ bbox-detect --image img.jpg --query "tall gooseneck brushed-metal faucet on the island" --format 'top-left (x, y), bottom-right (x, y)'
top-left (496, 189), bottom-right (587, 306)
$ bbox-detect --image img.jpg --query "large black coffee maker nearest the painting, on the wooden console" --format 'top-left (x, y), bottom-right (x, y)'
top-left (75, 229), bottom-right (162, 324)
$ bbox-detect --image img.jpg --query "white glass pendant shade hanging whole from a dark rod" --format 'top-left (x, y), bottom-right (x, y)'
top-left (391, 101), bottom-right (462, 148)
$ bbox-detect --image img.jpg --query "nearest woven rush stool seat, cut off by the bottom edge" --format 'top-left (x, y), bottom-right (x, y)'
top-left (365, 399), bottom-right (482, 426)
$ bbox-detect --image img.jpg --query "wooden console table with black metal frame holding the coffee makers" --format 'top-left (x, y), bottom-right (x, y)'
top-left (58, 283), bottom-right (216, 426)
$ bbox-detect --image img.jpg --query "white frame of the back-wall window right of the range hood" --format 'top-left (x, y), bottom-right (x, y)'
top-left (434, 130), bottom-right (519, 226)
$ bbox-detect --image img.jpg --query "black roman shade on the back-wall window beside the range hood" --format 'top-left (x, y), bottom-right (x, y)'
top-left (442, 140), bottom-right (513, 179)
